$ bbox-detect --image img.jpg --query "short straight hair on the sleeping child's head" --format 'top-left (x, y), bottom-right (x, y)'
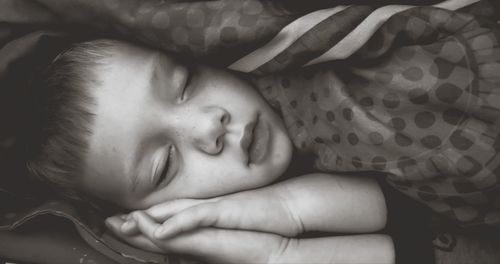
top-left (26, 39), bottom-right (119, 206)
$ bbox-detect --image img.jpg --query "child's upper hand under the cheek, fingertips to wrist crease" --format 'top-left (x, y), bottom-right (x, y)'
top-left (110, 186), bottom-right (303, 239)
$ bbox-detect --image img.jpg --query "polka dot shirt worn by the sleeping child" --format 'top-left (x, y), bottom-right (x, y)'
top-left (256, 7), bottom-right (500, 226)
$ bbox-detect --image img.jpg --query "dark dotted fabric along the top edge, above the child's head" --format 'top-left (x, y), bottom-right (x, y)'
top-left (32, 0), bottom-right (297, 62)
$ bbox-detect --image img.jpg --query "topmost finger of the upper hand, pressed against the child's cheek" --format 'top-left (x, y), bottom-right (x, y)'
top-left (146, 199), bottom-right (210, 222)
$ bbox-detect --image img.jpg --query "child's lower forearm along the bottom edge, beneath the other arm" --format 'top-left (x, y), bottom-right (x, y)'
top-left (269, 234), bottom-right (395, 264)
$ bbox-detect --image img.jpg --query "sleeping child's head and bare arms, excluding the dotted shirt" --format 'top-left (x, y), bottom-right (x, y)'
top-left (28, 40), bottom-right (394, 263)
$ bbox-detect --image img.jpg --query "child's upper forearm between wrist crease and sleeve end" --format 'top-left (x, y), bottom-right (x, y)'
top-left (275, 174), bottom-right (387, 232)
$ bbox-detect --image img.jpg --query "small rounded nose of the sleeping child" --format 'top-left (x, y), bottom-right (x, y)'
top-left (193, 106), bottom-right (230, 155)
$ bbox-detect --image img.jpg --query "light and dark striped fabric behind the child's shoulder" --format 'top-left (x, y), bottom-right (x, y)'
top-left (229, 0), bottom-right (479, 74)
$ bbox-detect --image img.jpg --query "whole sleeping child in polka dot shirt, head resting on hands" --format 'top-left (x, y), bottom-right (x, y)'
top-left (28, 4), bottom-right (500, 263)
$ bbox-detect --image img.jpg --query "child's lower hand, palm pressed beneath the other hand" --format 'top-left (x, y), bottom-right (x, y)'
top-left (106, 211), bottom-right (290, 263)
